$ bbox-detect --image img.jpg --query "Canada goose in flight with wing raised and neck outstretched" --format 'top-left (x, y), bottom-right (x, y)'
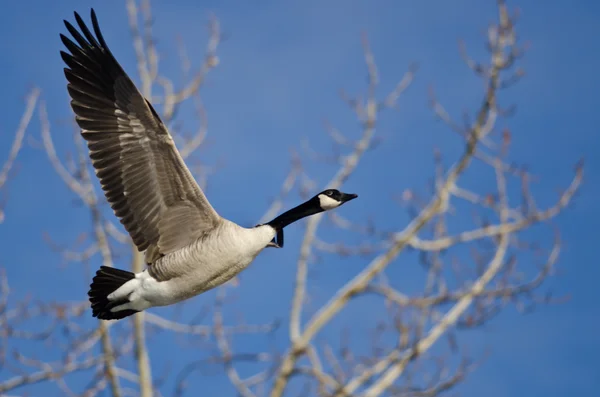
top-left (60, 9), bottom-right (357, 320)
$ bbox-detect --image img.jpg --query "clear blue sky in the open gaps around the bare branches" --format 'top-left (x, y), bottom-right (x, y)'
top-left (0, 0), bottom-right (600, 397)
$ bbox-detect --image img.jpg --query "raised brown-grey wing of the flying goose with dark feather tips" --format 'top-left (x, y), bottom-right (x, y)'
top-left (60, 9), bottom-right (220, 261)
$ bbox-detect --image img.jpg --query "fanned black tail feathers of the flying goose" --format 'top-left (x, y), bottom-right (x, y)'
top-left (88, 266), bottom-right (137, 320)
